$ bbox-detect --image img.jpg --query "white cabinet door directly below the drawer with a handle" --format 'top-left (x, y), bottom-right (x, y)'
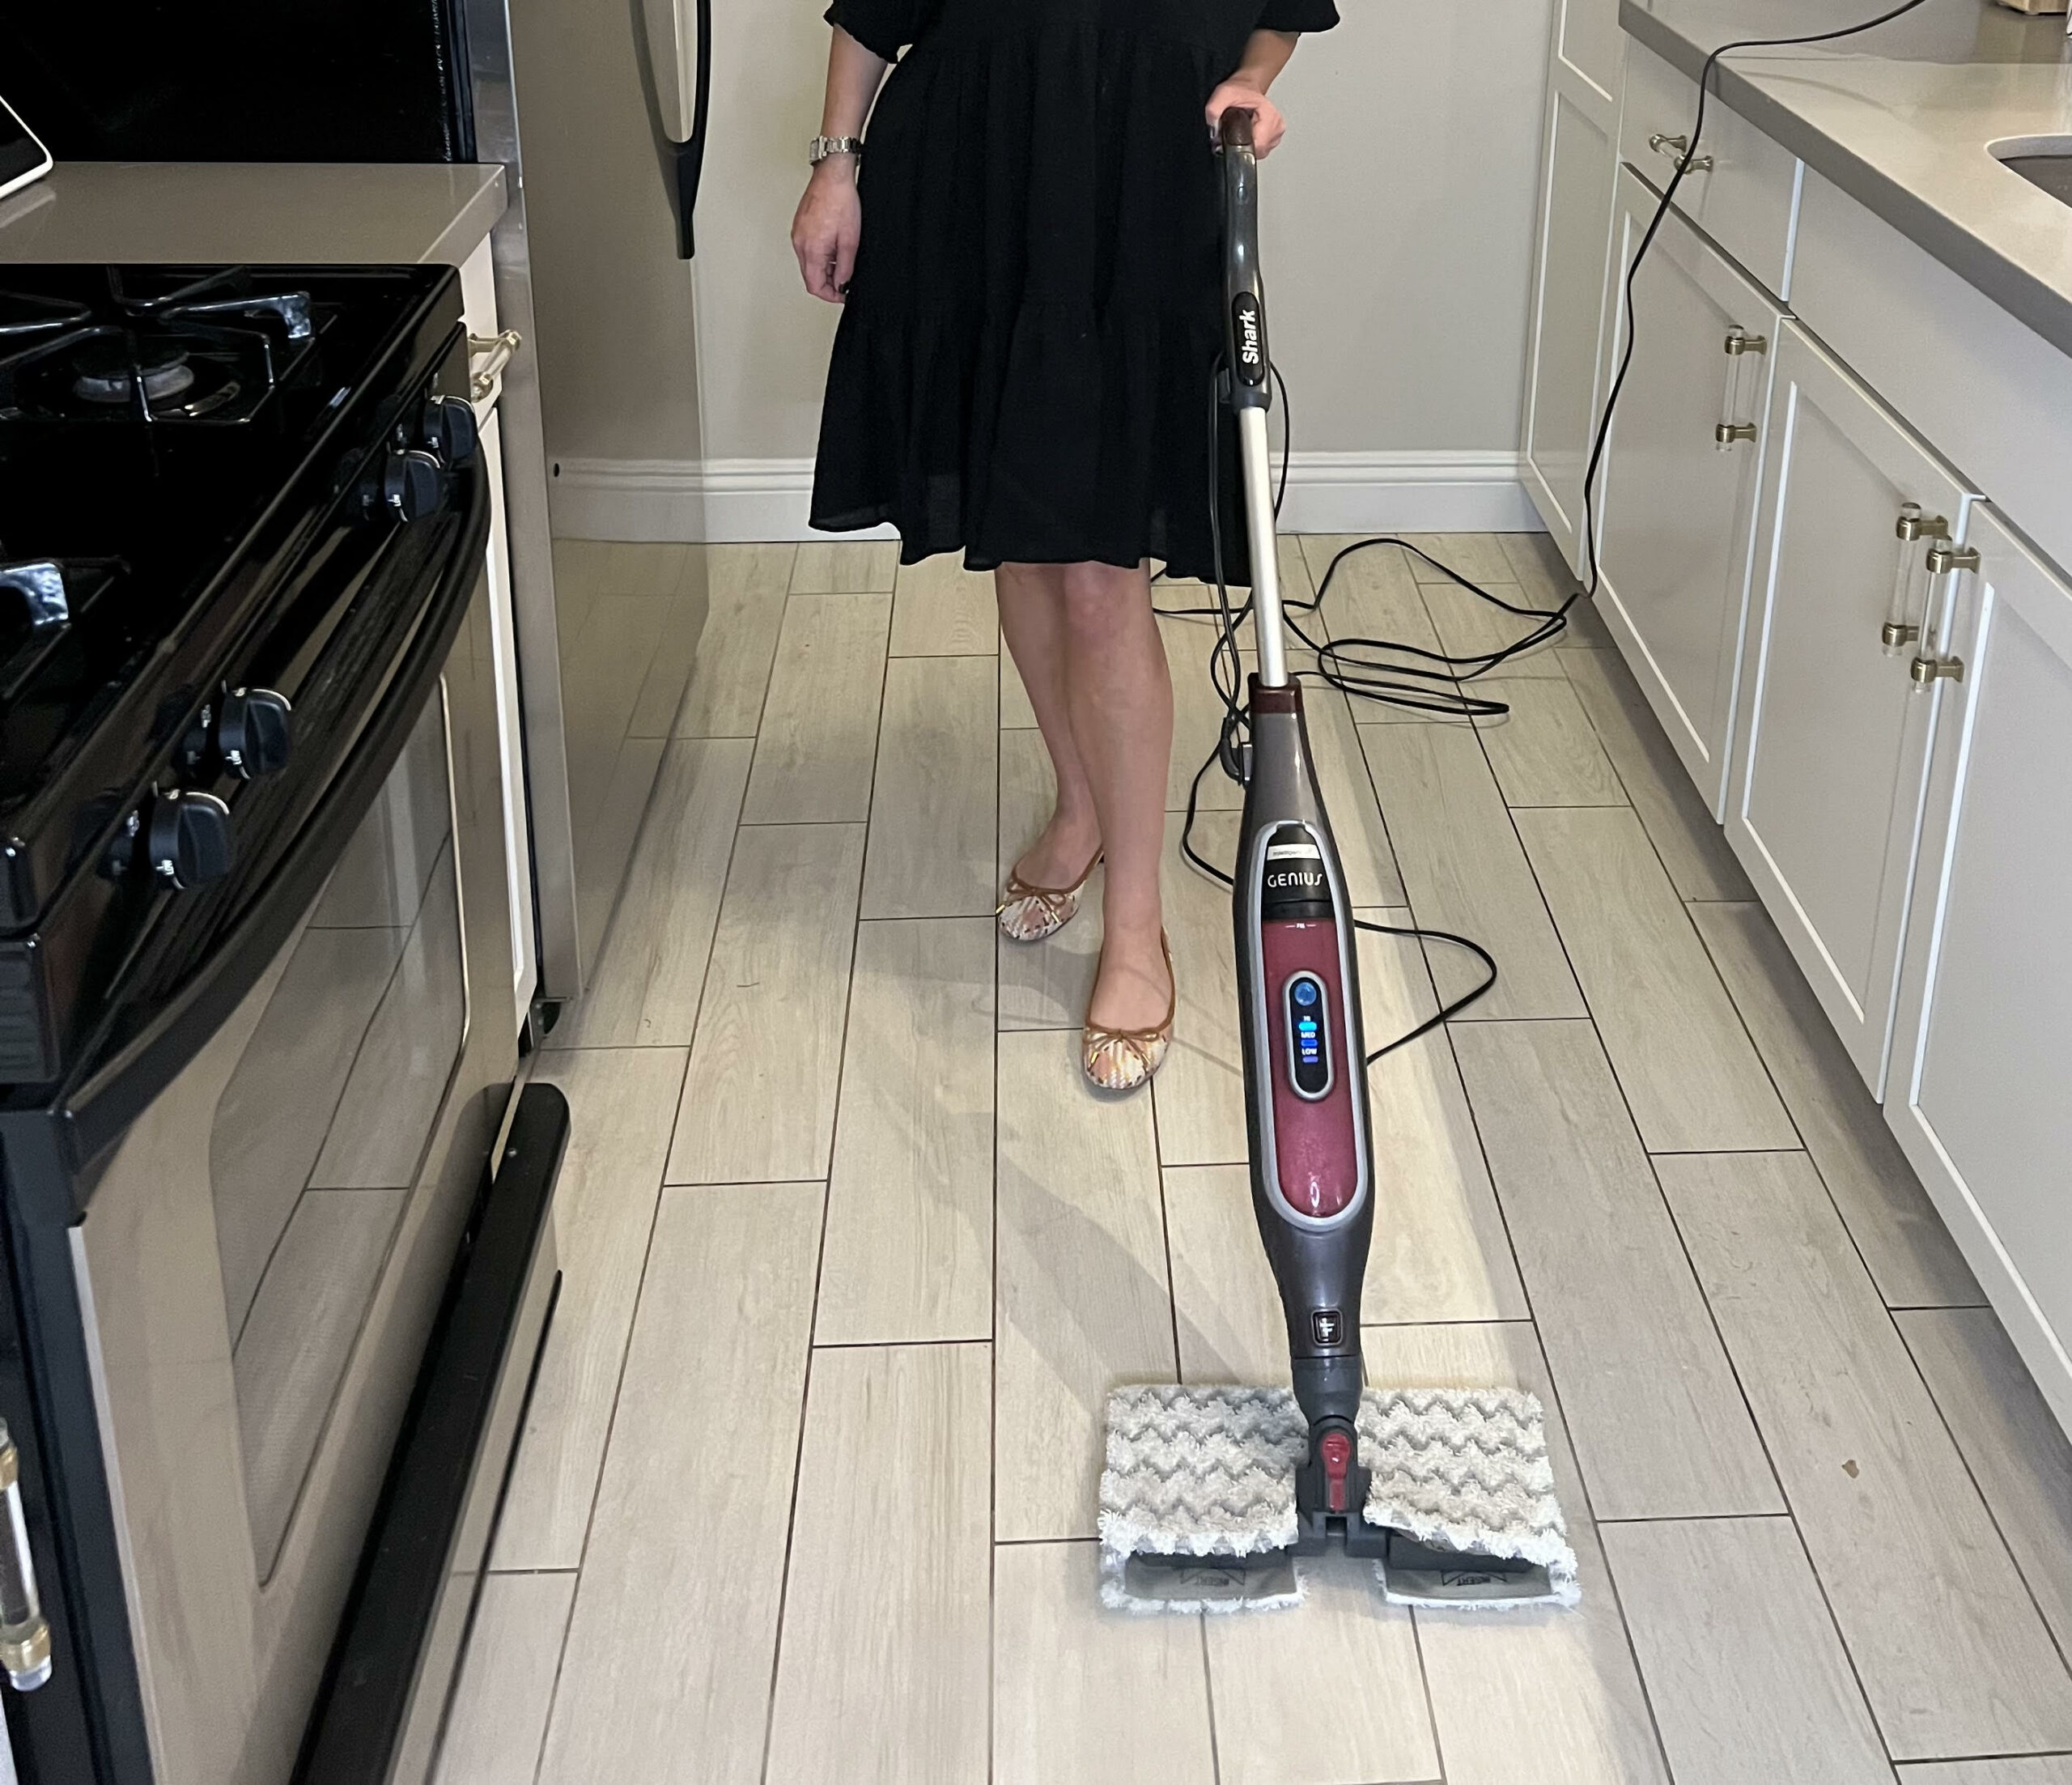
top-left (1598, 172), bottom-right (1782, 819)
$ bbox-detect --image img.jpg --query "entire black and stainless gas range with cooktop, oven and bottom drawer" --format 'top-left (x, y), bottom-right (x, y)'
top-left (0, 267), bottom-right (566, 1785)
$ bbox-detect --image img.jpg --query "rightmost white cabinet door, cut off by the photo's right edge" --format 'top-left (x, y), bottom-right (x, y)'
top-left (1886, 510), bottom-right (2072, 1429)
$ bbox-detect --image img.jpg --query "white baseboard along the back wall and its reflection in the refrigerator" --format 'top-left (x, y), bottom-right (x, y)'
top-left (547, 452), bottom-right (1539, 543)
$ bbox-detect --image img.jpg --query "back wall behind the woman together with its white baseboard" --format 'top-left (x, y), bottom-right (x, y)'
top-left (549, 0), bottom-right (1550, 539)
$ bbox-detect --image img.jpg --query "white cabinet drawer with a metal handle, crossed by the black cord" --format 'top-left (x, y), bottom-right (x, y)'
top-left (1618, 44), bottom-right (1801, 296)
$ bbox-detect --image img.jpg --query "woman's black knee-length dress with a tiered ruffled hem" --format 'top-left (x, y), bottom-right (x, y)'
top-left (813, 0), bottom-right (1339, 580)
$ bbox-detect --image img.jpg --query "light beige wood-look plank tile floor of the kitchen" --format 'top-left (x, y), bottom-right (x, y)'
top-left (437, 535), bottom-right (2072, 1785)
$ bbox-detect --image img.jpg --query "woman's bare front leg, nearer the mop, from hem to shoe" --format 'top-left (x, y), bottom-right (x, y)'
top-left (1060, 564), bottom-right (1173, 1028)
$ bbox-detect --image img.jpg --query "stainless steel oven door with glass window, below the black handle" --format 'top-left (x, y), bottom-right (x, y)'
top-left (8, 508), bottom-right (516, 1785)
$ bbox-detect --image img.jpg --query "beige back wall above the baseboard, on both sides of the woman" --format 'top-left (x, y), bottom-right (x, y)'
top-left (698, 0), bottom-right (1548, 458)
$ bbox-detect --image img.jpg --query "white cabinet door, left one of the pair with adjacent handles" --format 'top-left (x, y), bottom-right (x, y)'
top-left (1726, 324), bottom-right (1975, 1094)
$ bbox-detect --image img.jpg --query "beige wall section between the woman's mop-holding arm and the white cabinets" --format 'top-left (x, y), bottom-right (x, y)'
top-left (1259, 0), bottom-right (1550, 452)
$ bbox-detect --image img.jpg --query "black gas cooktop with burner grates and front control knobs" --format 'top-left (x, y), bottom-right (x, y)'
top-left (0, 266), bottom-right (474, 1084)
